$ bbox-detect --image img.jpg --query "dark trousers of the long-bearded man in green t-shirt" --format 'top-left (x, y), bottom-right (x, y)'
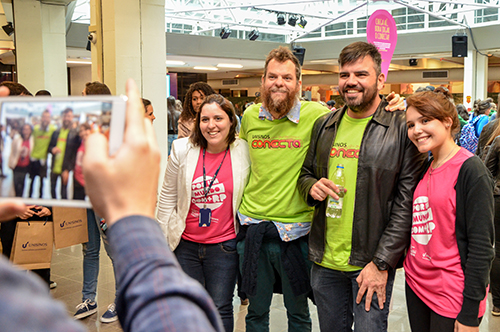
top-left (238, 240), bottom-right (312, 332)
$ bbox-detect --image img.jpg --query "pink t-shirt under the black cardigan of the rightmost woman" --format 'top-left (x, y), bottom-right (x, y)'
top-left (404, 149), bottom-right (486, 319)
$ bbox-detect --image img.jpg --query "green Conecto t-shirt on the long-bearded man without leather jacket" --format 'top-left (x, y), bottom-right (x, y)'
top-left (239, 102), bottom-right (329, 223)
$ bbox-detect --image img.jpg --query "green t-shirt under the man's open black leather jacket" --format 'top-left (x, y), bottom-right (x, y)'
top-left (320, 113), bottom-right (372, 271)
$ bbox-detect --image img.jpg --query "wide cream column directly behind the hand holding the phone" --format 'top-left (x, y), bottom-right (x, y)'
top-left (89, 0), bottom-right (168, 185)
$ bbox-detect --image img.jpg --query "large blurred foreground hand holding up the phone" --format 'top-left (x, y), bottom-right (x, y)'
top-left (83, 80), bottom-right (161, 226)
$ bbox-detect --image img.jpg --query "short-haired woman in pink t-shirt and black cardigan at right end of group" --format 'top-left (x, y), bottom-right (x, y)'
top-left (404, 88), bottom-right (494, 332)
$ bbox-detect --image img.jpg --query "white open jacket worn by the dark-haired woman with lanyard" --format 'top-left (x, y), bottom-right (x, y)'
top-left (157, 137), bottom-right (250, 250)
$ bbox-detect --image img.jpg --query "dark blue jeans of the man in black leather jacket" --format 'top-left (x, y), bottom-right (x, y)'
top-left (311, 264), bottom-right (396, 332)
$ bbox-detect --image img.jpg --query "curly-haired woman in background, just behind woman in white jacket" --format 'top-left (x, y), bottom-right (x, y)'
top-left (177, 82), bottom-right (215, 138)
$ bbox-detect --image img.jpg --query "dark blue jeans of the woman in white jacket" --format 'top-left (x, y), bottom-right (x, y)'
top-left (174, 239), bottom-right (238, 332)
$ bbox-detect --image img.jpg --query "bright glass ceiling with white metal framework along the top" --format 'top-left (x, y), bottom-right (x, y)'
top-left (72, 0), bottom-right (500, 43)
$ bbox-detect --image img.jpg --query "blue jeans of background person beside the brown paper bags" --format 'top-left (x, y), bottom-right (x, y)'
top-left (82, 209), bottom-right (118, 302)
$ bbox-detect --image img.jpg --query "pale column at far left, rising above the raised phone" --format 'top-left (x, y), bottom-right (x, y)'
top-left (12, 0), bottom-right (71, 96)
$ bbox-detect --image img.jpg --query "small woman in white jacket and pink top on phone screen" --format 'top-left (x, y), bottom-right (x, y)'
top-left (9, 123), bottom-right (34, 197)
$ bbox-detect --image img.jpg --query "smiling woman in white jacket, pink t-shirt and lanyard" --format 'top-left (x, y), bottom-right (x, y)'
top-left (158, 95), bottom-right (250, 332)
